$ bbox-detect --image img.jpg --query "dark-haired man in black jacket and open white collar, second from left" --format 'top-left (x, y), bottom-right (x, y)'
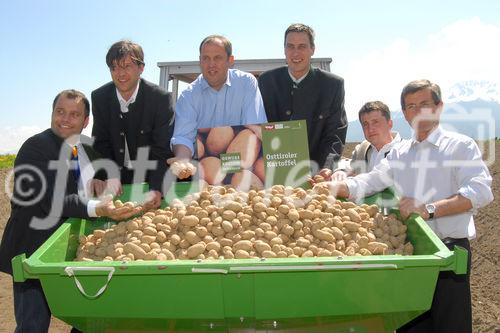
top-left (92, 40), bottom-right (174, 208)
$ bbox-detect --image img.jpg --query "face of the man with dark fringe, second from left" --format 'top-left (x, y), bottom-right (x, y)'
top-left (110, 54), bottom-right (144, 100)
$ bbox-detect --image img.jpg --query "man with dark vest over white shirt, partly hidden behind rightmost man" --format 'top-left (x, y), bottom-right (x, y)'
top-left (332, 101), bottom-right (401, 180)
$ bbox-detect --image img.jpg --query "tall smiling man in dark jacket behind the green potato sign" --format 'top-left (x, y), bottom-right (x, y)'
top-left (259, 24), bottom-right (347, 169)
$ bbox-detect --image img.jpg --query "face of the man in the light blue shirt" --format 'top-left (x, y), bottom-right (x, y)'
top-left (200, 41), bottom-right (234, 90)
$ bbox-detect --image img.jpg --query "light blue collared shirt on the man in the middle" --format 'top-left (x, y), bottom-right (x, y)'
top-left (170, 69), bottom-right (267, 154)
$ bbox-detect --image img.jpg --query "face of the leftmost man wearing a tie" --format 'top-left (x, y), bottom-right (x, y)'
top-left (50, 95), bottom-right (89, 139)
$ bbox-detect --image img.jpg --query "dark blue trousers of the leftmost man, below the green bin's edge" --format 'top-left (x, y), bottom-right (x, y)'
top-left (13, 280), bottom-right (81, 333)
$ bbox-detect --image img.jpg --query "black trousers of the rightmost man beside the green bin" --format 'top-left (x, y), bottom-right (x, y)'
top-left (397, 238), bottom-right (472, 333)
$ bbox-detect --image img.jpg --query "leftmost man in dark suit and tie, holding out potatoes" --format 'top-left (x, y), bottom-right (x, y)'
top-left (0, 90), bottom-right (139, 333)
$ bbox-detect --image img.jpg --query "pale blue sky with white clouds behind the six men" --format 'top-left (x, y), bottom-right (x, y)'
top-left (0, 0), bottom-right (500, 154)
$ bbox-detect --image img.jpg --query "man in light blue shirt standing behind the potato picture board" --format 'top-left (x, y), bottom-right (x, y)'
top-left (168, 35), bottom-right (267, 169)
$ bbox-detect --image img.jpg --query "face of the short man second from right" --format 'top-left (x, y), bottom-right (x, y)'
top-left (360, 110), bottom-right (392, 149)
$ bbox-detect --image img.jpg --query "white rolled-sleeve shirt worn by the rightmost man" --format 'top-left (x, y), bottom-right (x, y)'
top-left (346, 127), bottom-right (493, 239)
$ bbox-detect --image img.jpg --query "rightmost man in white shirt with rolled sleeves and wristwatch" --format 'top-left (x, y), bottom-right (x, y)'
top-left (328, 80), bottom-right (493, 333)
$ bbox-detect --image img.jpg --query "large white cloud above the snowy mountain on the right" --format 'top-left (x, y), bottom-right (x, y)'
top-left (344, 17), bottom-right (500, 120)
